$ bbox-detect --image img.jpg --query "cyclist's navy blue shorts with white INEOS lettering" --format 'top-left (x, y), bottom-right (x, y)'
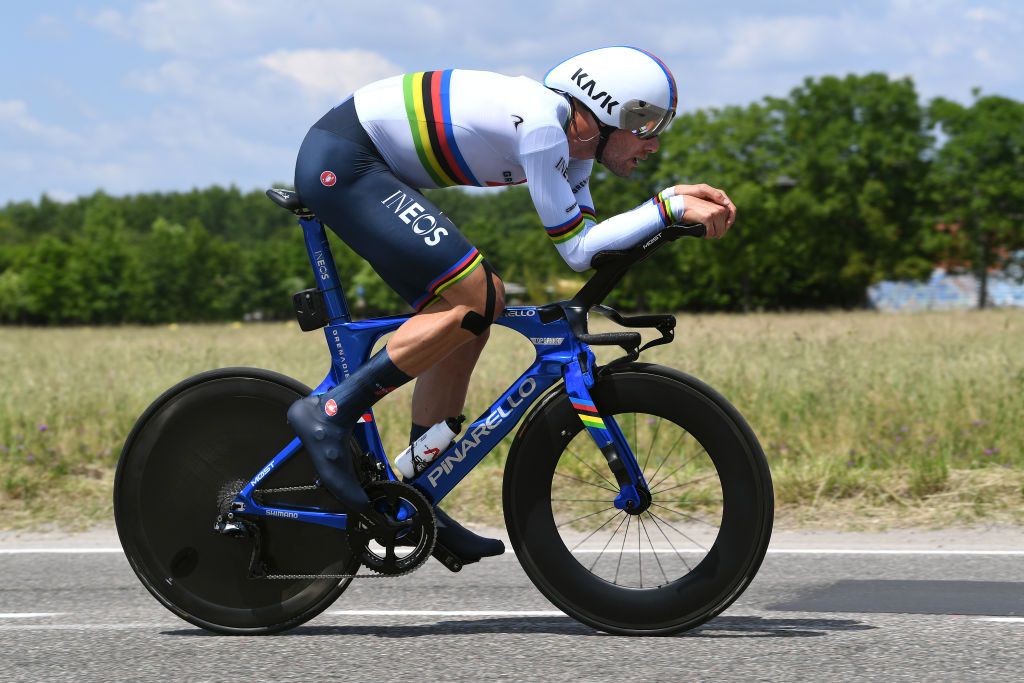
top-left (295, 98), bottom-right (483, 311)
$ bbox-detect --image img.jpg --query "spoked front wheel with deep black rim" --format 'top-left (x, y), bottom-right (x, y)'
top-left (504, 364), bottom-right (773, 635)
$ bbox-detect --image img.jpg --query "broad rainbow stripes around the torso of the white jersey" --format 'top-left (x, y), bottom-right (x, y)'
top-left (401, 69), bottom-right (480, 187)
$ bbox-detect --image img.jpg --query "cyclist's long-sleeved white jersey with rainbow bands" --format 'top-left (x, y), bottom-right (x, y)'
top-left (354, 70), bottom-right (684, 271)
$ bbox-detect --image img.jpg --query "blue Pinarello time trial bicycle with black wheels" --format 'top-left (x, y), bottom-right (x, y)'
top-left (114, 189), bottom-right (773, 635)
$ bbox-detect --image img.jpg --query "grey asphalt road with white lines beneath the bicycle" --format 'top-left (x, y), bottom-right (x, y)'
top-left (0, 537), bottom-right (1024, 681)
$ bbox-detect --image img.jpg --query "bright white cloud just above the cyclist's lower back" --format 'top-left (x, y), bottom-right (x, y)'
top-left (258, 49), bottom-right (402, 99)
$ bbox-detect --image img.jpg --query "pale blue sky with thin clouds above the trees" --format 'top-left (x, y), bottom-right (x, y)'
top-left (0, 0), bottom-right (1024, 204)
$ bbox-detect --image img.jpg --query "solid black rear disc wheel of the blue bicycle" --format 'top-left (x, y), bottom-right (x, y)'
top-left (114, 368), bottom-right (359, 634)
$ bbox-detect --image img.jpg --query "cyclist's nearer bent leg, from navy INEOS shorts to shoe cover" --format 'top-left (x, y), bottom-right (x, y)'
top-left (289, 109), bottom-right (504, 520)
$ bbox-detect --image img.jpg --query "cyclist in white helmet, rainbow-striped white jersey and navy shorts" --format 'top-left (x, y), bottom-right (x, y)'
top-left (288, 47), bottom-right (736, 561)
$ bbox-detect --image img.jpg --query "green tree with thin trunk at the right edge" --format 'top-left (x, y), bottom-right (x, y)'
top-left (929, 91), bottom-right (1024, 308)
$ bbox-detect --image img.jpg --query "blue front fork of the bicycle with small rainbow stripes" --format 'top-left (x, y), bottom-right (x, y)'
top-left (564, 346), bottom-right (650, 514)
